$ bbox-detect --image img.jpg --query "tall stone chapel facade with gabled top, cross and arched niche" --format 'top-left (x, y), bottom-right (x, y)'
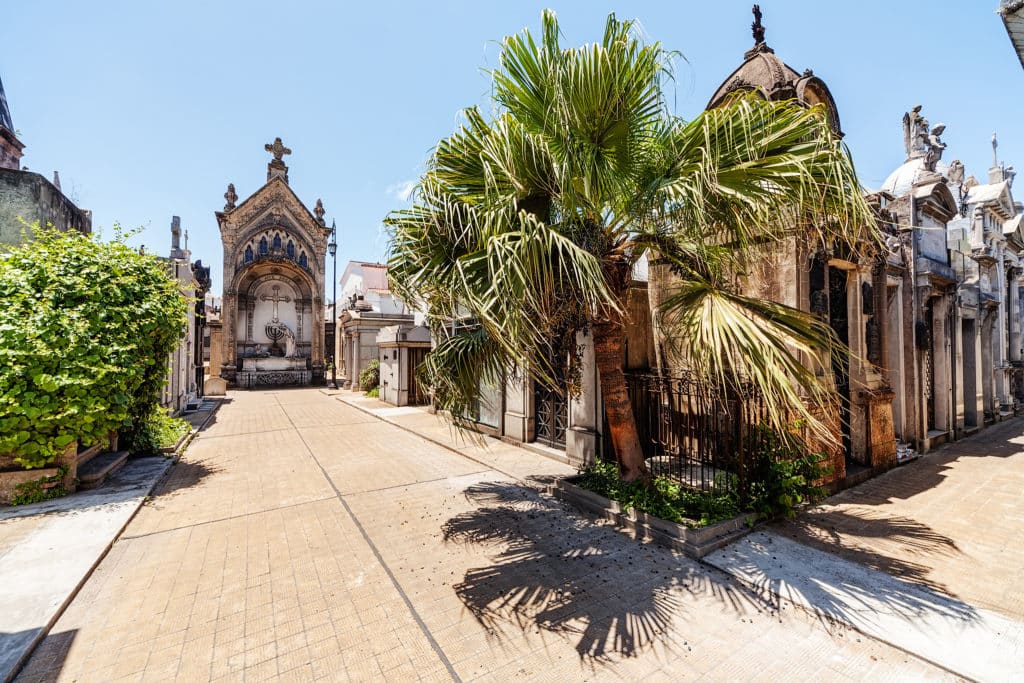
top-left (216, 137), bottom-right (331, 388)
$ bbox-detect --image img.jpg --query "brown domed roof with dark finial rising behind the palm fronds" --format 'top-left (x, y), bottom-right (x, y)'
top-left (705, 5), bottom-right (843, 135)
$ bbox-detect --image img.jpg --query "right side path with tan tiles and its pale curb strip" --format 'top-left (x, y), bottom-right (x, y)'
top-left (706, 420), bottom-right (1024, 681)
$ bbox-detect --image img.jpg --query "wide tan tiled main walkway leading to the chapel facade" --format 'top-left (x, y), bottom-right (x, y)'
top-left (18, 389), bottom-right (949, 682)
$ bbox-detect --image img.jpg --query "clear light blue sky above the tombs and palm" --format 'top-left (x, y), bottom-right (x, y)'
top-left (0, 0), bottom-right (1024, 292)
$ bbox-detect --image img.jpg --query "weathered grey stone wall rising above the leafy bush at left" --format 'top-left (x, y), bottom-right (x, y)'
top-left (0, 168), bottom-right (92, 245)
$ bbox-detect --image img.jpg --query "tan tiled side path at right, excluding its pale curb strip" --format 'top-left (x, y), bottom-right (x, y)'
top-left (774, 418), bottom-right (1024, 621)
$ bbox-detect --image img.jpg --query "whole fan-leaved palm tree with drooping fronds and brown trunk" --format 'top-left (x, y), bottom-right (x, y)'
top-left (386, 10), bottom-right (871, 480)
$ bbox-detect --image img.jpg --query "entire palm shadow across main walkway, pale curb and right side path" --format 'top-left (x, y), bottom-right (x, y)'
top-left (442, 482), bottom-right (978, 665)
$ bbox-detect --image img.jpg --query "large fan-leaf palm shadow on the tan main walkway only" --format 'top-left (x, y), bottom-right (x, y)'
top-left (442, 483), bottom-right (755, 663)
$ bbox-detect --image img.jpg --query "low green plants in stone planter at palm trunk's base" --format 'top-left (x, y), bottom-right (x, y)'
top-left (577, 461), bottom-right (739, 526)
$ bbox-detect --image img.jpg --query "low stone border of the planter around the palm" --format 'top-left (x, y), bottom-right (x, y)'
top-left (548, 476), bottom-right (758, 558)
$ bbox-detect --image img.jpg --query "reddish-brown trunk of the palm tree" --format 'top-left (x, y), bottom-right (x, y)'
top-left (593, 315), bottom-right (650, 481)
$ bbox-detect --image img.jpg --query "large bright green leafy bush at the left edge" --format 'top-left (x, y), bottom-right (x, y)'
top-left (0, 224), bottom-right (187, 468)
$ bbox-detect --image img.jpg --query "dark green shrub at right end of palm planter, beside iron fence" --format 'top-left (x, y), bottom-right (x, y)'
top-left (749, 426), bottom-right (828, 517)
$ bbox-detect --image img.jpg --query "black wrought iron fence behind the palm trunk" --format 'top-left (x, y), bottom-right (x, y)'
top-left (626, 373), bottom-right (766, 497)
